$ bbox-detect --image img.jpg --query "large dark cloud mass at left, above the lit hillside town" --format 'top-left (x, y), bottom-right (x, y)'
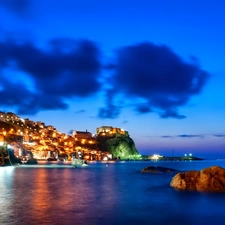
top-left (0, 39), bottom-right (101, 114)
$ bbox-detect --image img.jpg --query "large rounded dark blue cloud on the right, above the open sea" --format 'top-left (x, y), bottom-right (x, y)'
top-left (100, 42), bottom-right (209, 119)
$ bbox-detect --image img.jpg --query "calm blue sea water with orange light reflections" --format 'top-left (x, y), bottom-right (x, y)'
top-left (0, 160), bottom-right (225, 225)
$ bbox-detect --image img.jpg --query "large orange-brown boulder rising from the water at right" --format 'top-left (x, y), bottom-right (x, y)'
top-left (170, 166), bottom-right (225, 192)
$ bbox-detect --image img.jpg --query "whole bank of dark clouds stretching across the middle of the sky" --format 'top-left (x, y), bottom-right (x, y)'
top-left (0, 38), bottom-right (209, 119)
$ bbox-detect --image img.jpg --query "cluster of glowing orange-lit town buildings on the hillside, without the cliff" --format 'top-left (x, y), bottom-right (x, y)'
top-left (0, 112), bottom-right (129, 160)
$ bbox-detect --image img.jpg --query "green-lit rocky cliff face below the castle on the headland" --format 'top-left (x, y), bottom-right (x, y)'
top-left (98, 136), bottom-right (138, 159)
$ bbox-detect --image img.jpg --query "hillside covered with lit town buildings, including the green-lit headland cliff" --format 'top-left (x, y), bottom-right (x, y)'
top-left (0, 112), bottom-right (138, 160)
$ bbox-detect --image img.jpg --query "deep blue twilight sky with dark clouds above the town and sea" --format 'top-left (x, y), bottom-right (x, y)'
top-left (0, 0), bottom-right (225, 157)
